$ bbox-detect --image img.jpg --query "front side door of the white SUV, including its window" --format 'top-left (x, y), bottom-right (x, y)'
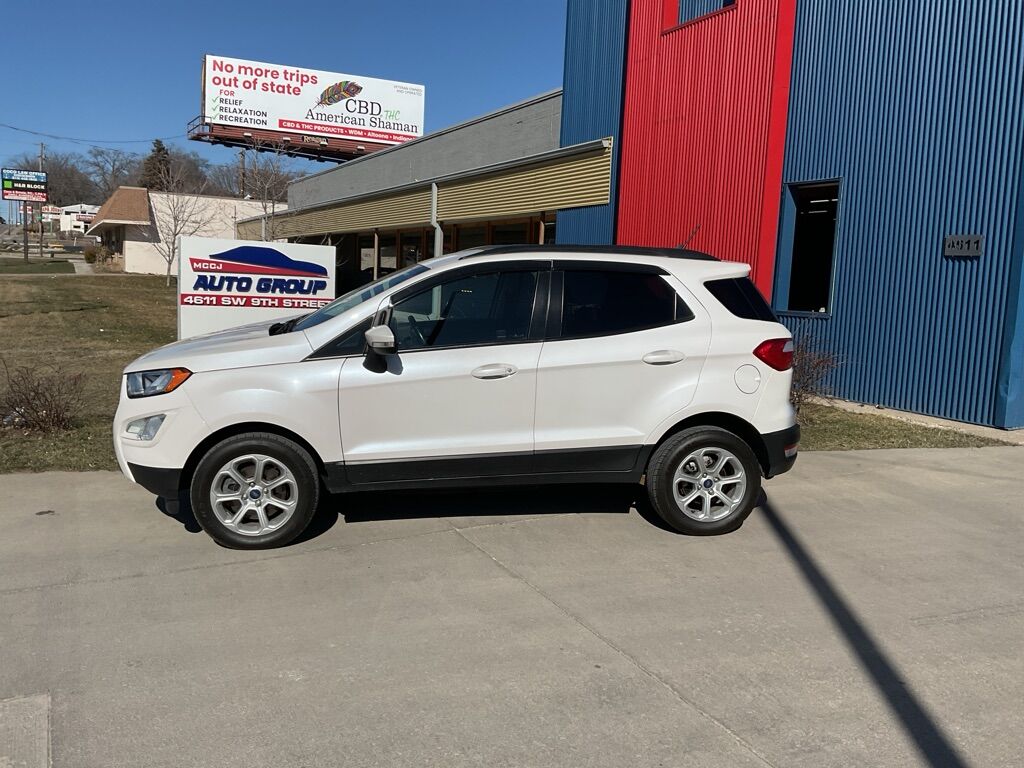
top-left (339, 262), bottom-right (548, 483)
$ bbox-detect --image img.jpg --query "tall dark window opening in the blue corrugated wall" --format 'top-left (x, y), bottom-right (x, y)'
top-left (780, 181), bottom-right (839, 312)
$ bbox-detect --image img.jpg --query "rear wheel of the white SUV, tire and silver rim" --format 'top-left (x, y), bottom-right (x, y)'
top-left (647, 427), bottom-right (761, 536)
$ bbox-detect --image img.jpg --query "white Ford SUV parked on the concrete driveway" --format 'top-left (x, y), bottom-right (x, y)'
top-left (114, 246), bottom-right (800, 548)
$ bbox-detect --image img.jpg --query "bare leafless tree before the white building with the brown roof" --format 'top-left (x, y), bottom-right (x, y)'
top-left (150, 163), bottom-right (215, 286)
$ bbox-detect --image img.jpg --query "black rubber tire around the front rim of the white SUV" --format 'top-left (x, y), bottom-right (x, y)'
top-left (189, 432), bottom-right (319, 549)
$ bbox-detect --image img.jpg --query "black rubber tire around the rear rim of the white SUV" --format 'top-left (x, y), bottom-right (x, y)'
top-left (647, 427), bottom-right (761, 536)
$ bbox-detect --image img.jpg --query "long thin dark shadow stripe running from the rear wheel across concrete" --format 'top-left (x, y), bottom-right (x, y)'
top-left (760, 498), bottom-right (967, 768)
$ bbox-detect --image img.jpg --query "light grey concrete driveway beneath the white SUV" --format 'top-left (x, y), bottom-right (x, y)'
top-left (0, 447), bottom-right (1024, 768)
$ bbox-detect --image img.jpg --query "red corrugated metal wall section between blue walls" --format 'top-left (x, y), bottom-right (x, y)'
top-left (617, 0), bottom-right (796, 295)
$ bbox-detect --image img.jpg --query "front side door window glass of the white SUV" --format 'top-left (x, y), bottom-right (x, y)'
top-left (389, 270), bottom-right (539, 351)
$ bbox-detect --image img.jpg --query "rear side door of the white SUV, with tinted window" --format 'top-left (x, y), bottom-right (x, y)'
top-left (535, 260), bottom-right (711, 471)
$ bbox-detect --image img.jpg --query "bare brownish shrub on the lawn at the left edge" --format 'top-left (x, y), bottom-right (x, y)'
top-left (0, 358), bottom-right (84, 432)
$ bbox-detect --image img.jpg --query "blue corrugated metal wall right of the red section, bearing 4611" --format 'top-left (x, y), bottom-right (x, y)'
top-left (778, 0), bottom-right (1024, 427)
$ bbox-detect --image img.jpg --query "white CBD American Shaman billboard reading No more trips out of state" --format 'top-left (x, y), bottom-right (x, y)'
top-left (202, 54), bottom-right (424, 144)
